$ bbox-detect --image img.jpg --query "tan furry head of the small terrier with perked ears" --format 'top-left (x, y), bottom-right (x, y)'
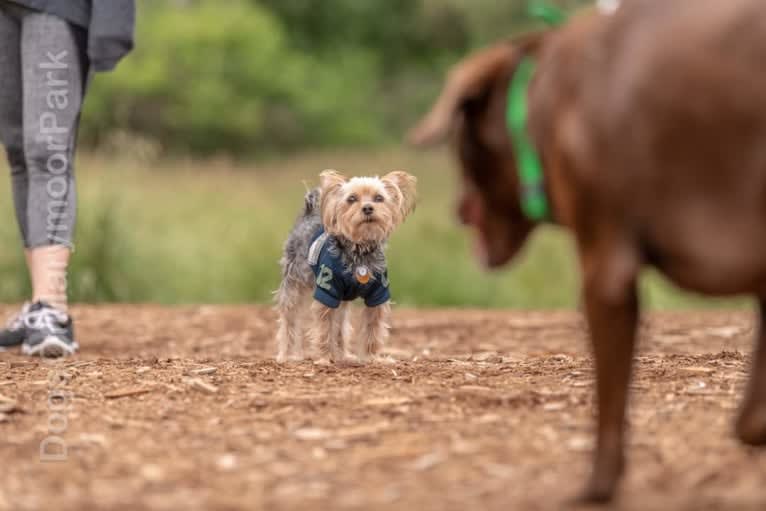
top-left (320, 170), bottom-right (417, 243)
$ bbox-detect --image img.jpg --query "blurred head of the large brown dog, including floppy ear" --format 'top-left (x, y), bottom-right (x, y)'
top-left (408, 38), bottom-right (537, 267)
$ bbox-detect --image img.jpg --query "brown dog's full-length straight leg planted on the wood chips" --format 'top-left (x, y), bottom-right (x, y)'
top-left (577, 247), bottom-right (638, 503)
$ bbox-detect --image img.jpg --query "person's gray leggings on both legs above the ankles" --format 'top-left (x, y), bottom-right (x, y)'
top-left (0, 0), bottom-right (88, 248)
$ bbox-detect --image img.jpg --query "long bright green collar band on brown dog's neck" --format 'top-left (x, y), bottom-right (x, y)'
top-left (506, 56), bottom-right (550, 222)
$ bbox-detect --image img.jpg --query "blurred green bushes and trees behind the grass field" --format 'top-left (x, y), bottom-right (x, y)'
top-left (81, 0), bottom-right (589, 157)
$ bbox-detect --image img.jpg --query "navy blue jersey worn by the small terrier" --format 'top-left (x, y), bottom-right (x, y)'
top-left (308, 227), bottom-right (391, 309)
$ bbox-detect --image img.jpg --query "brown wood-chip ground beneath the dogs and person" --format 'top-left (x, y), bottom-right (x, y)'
top-left (0, 306), bottom-right (766, 511)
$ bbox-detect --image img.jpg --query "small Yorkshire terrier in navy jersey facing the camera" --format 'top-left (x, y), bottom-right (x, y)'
top-left (276, 170), bottom-right (417, 363)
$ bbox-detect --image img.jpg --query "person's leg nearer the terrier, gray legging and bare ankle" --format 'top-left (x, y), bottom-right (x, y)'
top-left (21, 13), bottom-right (87, 311)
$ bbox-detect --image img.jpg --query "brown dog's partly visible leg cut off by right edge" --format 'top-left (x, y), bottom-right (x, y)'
top-left (737, 298), bottom-right (766, 446)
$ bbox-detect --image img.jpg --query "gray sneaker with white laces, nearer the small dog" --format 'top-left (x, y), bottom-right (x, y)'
top-left (21, 302), bottom-right (80, 358)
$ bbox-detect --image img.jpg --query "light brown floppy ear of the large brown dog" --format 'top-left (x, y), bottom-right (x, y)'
top-left (407, 43), bottom-right (517, 146)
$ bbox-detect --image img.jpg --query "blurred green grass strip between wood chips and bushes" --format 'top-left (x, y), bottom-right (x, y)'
top-left (0, 149), bottom-right (747, 308)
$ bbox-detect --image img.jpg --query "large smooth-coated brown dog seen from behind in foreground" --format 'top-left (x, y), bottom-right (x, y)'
top-left (410, 0), bottom-right (766, 501)
